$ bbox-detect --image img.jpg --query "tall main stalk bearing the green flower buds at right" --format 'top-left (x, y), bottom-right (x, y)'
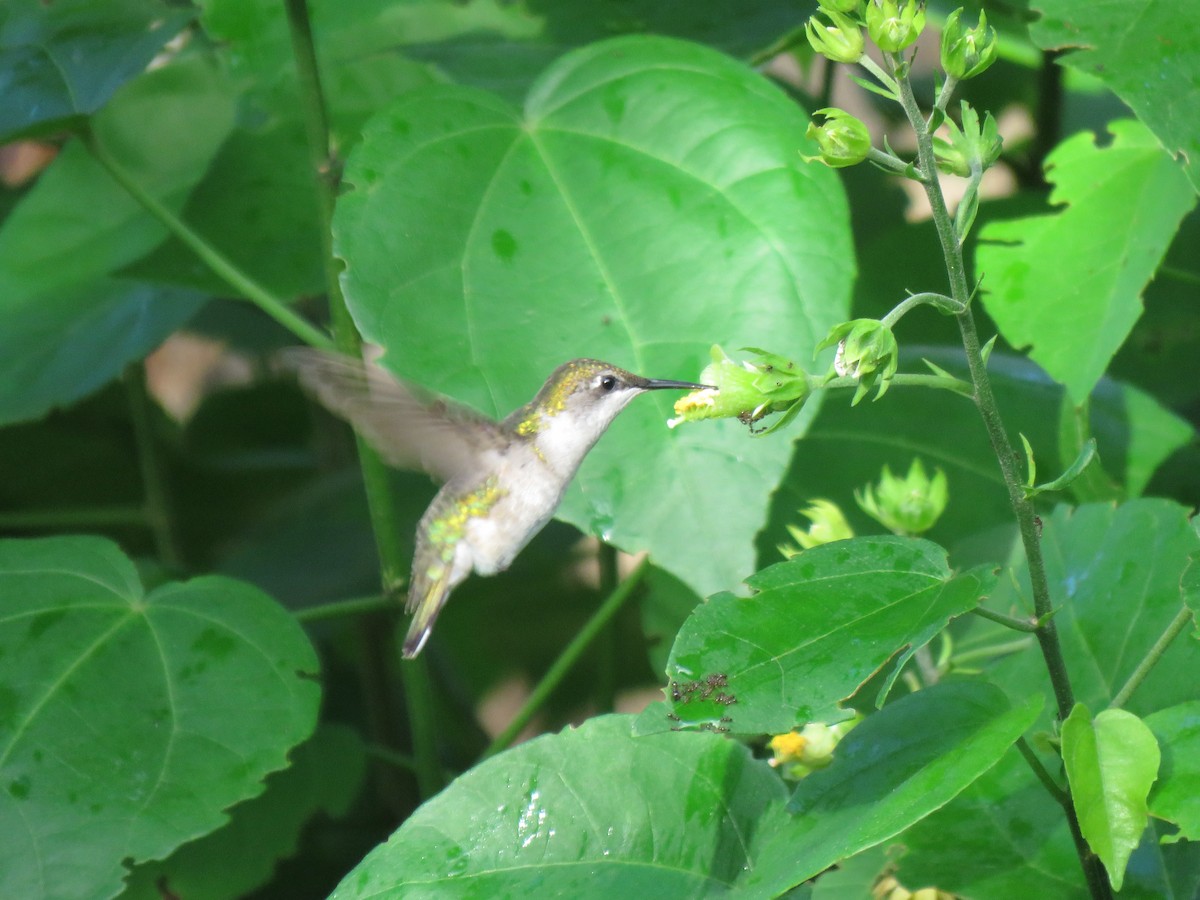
top-left (899, 65), bottom-right (1112, 900)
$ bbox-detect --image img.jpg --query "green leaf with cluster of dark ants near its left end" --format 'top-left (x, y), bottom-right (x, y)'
top-left (638, 535), bottom-right (992, 733)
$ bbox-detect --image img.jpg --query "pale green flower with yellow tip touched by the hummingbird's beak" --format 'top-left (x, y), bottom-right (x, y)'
top-left (667, 344), bottom-right (811, 428)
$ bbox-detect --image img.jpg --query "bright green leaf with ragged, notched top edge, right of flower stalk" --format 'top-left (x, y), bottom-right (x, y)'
top-left (976, 121), bottom-right (1195, 403)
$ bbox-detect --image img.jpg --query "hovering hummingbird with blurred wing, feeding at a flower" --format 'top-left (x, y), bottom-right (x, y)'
top-left (282, 348), bottom-right (708, 659)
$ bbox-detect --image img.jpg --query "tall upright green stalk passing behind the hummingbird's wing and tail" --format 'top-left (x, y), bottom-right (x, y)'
top-left (284, 0), bottom-right (443, 797)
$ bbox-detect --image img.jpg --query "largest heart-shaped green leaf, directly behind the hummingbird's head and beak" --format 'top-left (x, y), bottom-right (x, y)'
top-left (335, 38), bottom-right (853, 600)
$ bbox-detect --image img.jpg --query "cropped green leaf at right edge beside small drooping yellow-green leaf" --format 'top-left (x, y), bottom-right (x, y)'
top-left (1146, 701), bottom-right (1200, 841)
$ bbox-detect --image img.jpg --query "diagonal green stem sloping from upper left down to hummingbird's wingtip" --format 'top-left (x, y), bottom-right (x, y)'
top-left (82, 127), bottom-right (332, 349)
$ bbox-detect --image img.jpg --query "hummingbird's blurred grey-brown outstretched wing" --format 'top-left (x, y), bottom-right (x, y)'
top-left (280, 347), bottom-right (503, 481)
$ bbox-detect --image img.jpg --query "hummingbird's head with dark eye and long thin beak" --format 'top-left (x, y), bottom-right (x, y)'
top-left (512, 359), bottom-right (704, 464)
